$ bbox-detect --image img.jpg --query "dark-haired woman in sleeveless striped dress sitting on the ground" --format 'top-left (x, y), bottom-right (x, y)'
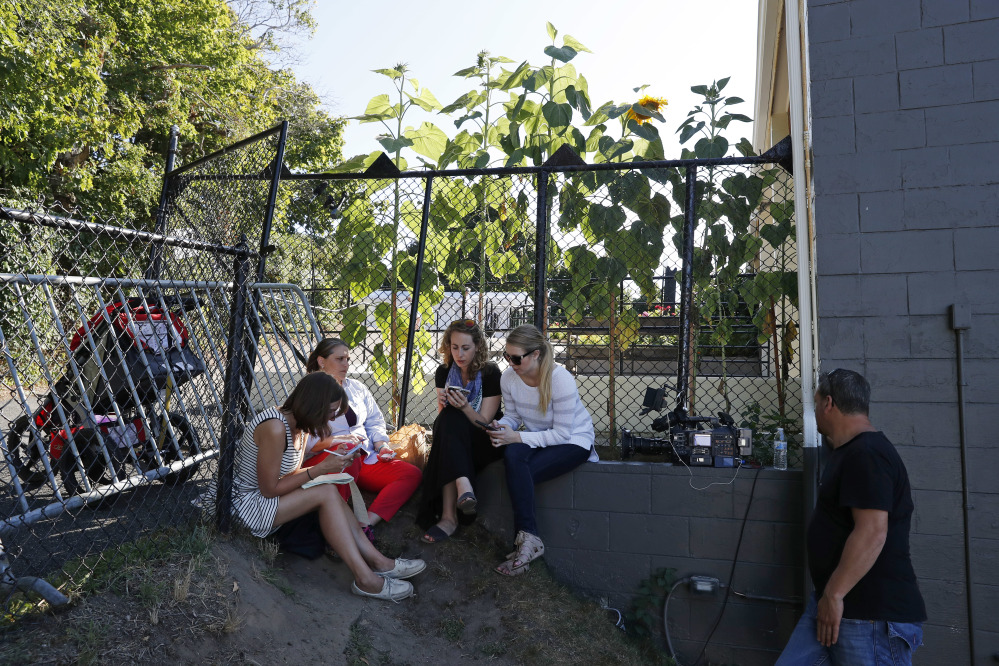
top-left (233, 372), bottom-right (426, 601)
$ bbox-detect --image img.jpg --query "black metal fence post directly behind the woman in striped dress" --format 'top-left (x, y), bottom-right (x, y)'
top-left (215, 234), bottom-right (252, 533)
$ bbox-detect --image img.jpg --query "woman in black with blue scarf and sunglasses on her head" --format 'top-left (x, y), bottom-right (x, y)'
top-left (416, 319), bottom-right (502, 543)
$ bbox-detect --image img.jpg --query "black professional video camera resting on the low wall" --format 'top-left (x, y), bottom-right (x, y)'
top-left (621, 388), bottom-right (753, 467)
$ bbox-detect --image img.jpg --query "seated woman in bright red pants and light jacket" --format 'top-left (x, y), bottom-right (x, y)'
top-left (305, 338), bottom-right (423, 539)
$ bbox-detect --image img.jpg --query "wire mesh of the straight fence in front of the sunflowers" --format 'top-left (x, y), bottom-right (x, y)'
top-left (276, 160), bottom-right (801, 462)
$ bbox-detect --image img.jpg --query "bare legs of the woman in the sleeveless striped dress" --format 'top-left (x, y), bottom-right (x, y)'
top-left (274, 484), bottom-right (394, 592)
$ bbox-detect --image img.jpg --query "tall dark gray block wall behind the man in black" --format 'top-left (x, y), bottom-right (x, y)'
top-left (808, 0), bottom-right (999, 664)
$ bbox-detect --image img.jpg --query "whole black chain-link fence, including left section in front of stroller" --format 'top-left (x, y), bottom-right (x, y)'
top-left (0, 125), bottom-right (801, 616)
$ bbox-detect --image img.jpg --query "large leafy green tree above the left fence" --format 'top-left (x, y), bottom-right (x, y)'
top-left (0, 0), bottom-right (344, 226)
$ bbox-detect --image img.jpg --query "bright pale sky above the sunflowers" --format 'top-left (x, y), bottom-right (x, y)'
top-left (293, 0), bottom-right (757, 163)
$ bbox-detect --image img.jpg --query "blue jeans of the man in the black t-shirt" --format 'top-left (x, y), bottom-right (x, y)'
top-left (777, 594), bottom-right (923, 666)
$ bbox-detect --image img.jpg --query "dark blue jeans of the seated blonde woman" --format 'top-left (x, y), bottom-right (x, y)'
top-left (504, 442), bottom-right (590, 536)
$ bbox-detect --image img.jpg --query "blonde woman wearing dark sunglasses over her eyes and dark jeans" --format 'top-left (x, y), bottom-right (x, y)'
top-left (489, 325), bottom-right (598, 576)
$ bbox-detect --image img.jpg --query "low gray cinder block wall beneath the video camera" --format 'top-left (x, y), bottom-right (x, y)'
top-left (476, 462), bottom-right (804, 666)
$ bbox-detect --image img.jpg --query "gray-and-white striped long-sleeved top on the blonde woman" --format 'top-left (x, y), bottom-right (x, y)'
top-left (499, 365), bottom-right (599, 461)
